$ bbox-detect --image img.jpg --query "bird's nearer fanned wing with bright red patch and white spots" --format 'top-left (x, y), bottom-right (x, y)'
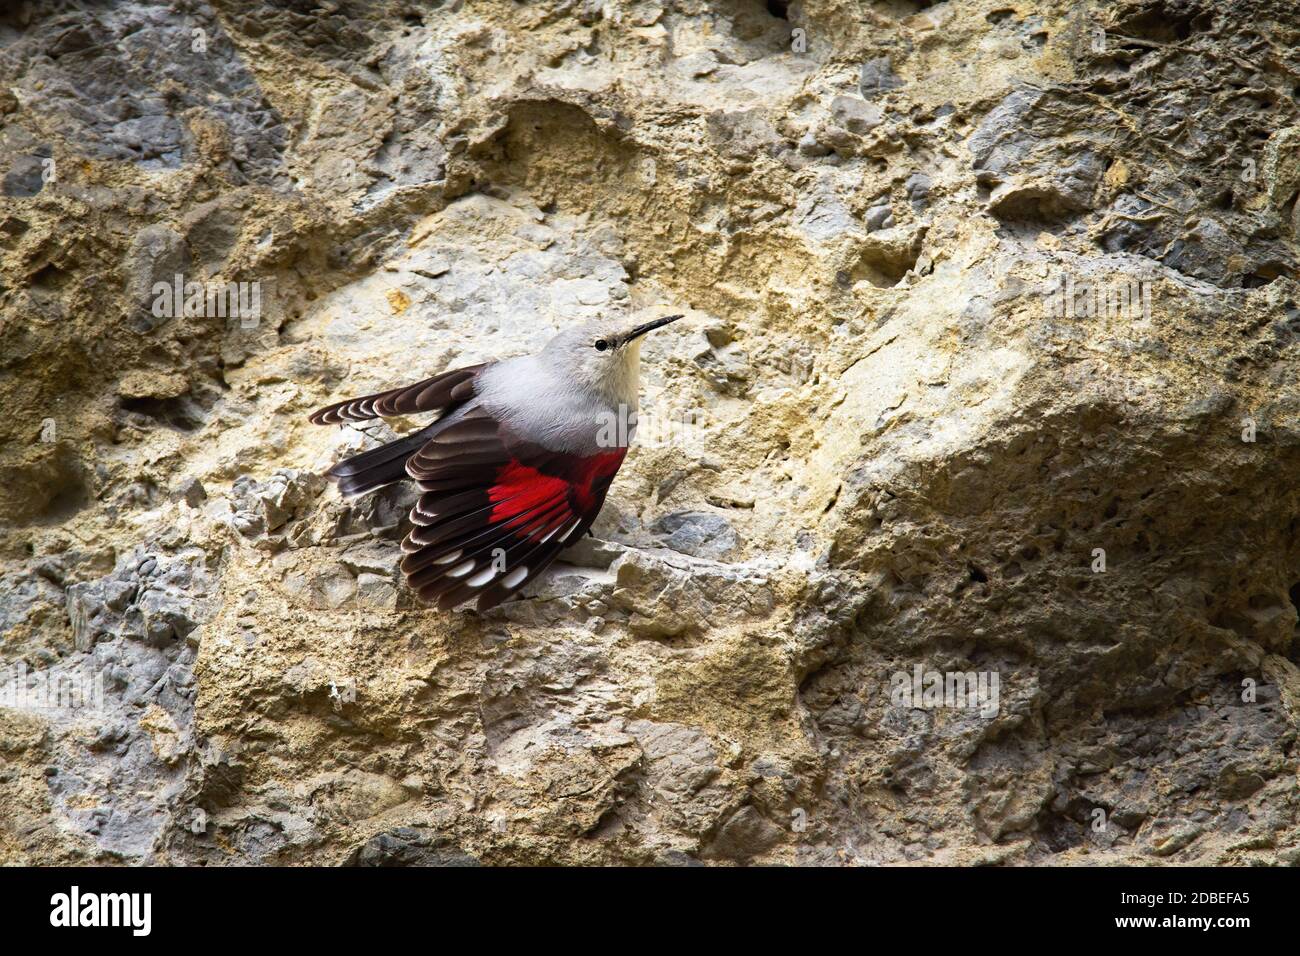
top-left (402, 407), bottom-right (627, 610)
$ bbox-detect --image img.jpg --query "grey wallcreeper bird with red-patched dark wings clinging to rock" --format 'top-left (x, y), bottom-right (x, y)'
top-left (311, 315), bottom-right (681, 610)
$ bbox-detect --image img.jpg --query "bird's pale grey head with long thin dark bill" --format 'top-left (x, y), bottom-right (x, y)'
top-left (542, 315), bottom-right (681, 408)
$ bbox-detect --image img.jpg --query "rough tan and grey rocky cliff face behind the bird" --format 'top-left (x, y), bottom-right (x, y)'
top-left (0, 0), bottom-right (1300, 865)
